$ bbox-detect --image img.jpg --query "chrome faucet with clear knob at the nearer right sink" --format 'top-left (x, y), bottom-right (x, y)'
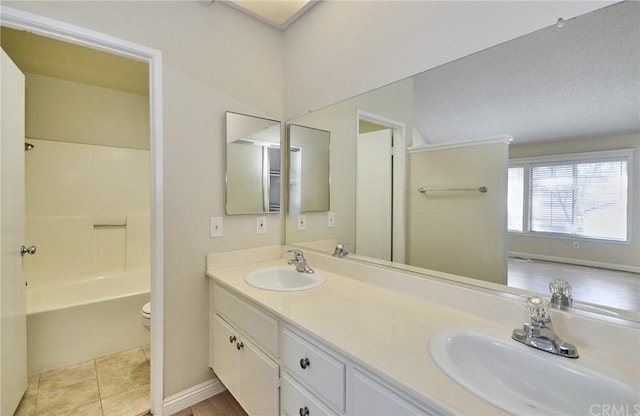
top-left (511, 296), bottom-right (578, 358)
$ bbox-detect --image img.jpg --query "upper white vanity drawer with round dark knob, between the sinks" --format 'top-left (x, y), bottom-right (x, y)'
top-left (281, 328), bottom-right (346, 412)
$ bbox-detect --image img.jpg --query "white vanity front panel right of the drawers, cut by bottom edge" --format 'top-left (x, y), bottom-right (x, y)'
top-left (352, 369), bottom-right (428, 416)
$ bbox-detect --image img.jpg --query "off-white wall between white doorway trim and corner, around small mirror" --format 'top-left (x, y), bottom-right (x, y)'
top-left (3, 1), bottom-right (283, 397)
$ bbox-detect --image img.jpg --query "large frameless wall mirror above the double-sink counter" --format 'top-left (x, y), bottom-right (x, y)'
top-left (286, 1), bottom-right (640, 321)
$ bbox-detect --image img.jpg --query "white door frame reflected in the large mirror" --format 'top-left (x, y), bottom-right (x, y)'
top-left (356, 110), bottom-right (407, 263)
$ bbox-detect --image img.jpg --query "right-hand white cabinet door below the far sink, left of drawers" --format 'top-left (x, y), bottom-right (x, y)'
top-left (238, 340), bottom-right (280, 415)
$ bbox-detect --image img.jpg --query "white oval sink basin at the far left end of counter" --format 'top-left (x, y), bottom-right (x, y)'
top-left (244, 267), bottom-right (325, 292)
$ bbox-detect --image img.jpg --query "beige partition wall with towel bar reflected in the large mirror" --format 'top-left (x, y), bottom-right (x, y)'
top-left (407, 141), bottom-right (508, 284)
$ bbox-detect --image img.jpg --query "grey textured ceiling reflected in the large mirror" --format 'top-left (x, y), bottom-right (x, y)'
top-left (413, 1), bottom-right (640, 144)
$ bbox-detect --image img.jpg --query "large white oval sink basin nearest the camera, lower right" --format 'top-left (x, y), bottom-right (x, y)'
top-left (430, 328), bottom-right (640, 415)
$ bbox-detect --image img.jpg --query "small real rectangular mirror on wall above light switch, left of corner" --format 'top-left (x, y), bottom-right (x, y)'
top-left (225, 111), bottom-right (281, 215)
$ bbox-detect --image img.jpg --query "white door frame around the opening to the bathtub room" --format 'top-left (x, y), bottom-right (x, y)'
top-left (0, 5), bottom-right (164, 416)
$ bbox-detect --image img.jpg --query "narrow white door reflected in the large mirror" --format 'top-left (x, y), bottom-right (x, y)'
top-left (355, 129), bottom-right (393, 260)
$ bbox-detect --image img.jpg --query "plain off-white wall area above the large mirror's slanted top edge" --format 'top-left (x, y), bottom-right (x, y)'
top-left (284, 1), bottom-right (614, 118)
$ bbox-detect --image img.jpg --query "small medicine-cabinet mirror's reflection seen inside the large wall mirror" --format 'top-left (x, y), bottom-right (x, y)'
top-left (288, 124), bottom-right (331, 214)
